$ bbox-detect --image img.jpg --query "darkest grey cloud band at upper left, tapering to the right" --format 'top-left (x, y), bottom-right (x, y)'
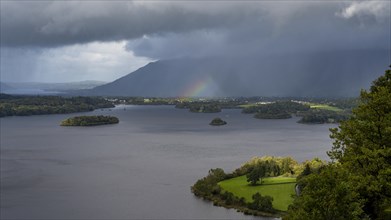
top-left (1, 1), bottom-right (264, 47)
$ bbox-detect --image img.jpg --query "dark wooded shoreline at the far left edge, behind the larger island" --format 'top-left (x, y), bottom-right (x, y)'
top-left (0, 94), bottom-right (114, 117)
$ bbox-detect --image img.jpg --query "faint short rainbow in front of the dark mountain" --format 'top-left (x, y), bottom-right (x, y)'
top-left (182, 76), bottom-right (217, 97)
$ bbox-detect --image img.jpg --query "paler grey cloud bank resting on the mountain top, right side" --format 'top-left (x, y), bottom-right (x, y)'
top-left (127, 2), bottom-right (390, 59)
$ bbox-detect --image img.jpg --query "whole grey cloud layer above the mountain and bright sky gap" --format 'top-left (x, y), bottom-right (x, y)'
top-left (1, 1), bottom-right (390, 52)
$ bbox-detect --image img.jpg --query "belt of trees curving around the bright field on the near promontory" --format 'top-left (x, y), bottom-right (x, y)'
top-left (191, 156), bottom-right (326, 217)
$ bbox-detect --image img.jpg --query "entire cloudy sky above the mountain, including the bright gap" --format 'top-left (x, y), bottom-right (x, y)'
top-left (0, 0), bottom-right (391, 82)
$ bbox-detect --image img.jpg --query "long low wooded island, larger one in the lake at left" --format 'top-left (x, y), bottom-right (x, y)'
top-left (60, 115), bottom-right (119, 126)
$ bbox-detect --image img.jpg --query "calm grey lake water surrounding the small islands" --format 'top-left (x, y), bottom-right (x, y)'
top-left (0, 106), bottom-right (331, 219)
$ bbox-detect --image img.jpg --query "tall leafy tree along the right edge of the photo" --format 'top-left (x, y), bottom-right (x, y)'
top-left (328, 66), bottom-right (391, 218)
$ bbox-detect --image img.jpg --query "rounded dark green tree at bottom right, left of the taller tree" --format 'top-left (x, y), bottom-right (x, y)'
top-left (283, 165), bottom-right (363, 220)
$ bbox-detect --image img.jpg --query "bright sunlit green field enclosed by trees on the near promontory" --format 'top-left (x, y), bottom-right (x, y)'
top-left (218, 176), bottom-right (296, 211)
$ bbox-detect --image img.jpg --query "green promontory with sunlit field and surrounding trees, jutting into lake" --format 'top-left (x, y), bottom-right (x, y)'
top-left (191, 156), bottom-right (298, 216)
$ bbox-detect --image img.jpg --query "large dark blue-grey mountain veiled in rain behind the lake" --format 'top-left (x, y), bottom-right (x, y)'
top-left (84, 50), bottom-right (390, 97)
